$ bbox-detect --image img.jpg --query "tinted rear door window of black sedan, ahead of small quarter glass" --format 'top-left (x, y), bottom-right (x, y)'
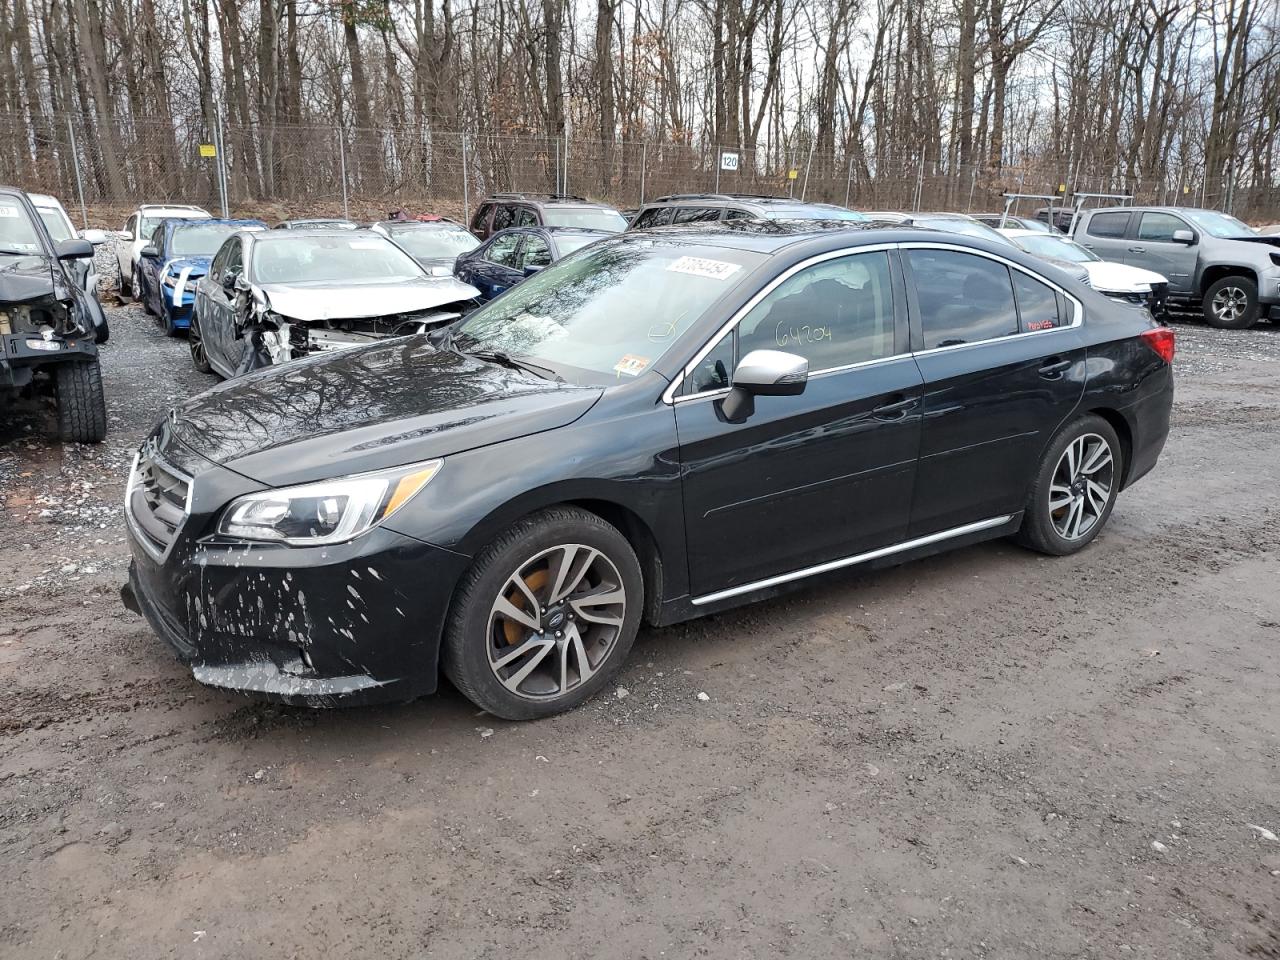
top-left (908, 250), bottom-right (1018, 349)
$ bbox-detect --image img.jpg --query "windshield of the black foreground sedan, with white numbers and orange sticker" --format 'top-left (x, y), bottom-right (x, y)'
top-left (454, 234), bottom-right (764, 384)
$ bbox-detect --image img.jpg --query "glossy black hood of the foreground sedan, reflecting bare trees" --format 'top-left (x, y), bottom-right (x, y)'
top-left (170, 337), bottom-right (602, 486)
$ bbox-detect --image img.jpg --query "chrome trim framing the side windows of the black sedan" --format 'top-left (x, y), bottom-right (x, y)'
top-left (662, 241), bottom-right (1084, 406)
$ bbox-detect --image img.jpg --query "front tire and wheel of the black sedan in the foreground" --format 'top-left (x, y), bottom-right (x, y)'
top-left (440, 507), bottom-right (644, 721)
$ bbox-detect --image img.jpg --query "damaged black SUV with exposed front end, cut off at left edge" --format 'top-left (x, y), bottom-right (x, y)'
top-left (0, 187), bottom-right (108, 443)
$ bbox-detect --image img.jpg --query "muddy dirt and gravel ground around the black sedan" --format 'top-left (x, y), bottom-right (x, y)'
top-left (0, 307), bottom-right (1280, 960)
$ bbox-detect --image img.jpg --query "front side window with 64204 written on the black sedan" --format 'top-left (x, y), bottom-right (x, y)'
top-left (739, 251), bottom-right (895, 371)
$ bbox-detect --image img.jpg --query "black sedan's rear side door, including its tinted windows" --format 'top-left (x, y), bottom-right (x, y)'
top-left (904, 244), bottom-right (1085, 539)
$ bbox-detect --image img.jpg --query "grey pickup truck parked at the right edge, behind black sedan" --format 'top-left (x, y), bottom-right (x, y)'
top-left (1073, 206), bottom-right (1280, 330)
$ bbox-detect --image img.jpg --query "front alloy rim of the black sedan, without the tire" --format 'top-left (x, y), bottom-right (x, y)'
top-left (486, 544), bottom-right (627, 700)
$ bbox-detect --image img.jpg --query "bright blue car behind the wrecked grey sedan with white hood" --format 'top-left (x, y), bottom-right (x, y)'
top-left (133, 219), bottom-right (266, 337)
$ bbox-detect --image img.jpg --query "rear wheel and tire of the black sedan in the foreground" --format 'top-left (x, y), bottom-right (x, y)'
top-left (1014, 413), bottom-right (1124, 557)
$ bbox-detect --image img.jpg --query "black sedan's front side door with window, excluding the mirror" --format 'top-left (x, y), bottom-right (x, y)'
top-left (675, 250), bottom-right (923, 602)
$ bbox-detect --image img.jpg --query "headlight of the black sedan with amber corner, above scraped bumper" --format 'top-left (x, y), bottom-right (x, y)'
top-left (218, 460), bottom-right (444, 547)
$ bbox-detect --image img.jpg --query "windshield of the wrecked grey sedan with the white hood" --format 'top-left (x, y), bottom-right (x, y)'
top-left (252, 232), bottom-right (424, 283)
